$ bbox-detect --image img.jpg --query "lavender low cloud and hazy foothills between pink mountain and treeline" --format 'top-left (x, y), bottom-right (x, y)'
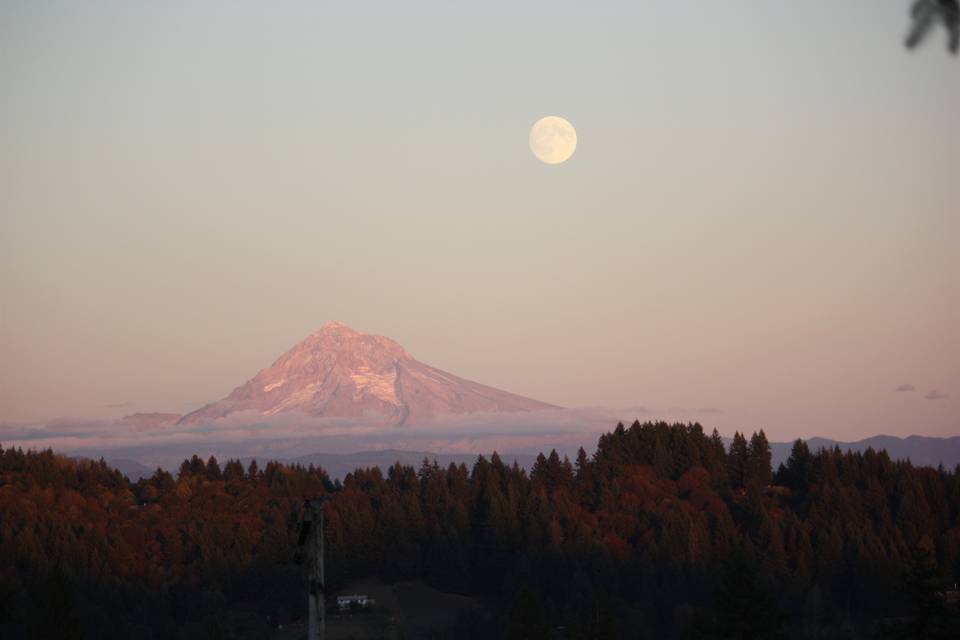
top-left (0, 407), bottom-right (752, 469)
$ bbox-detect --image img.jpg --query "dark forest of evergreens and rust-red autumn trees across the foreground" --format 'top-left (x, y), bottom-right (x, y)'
top-left (0, 423), bottom-right (960, 639)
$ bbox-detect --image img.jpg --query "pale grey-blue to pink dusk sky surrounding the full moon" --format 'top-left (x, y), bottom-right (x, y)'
top-left (0, 0), bottom-right (960, 439)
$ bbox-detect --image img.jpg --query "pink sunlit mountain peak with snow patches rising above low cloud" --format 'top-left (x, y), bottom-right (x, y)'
top-left (180, 322), bottom-right (559, 425)
